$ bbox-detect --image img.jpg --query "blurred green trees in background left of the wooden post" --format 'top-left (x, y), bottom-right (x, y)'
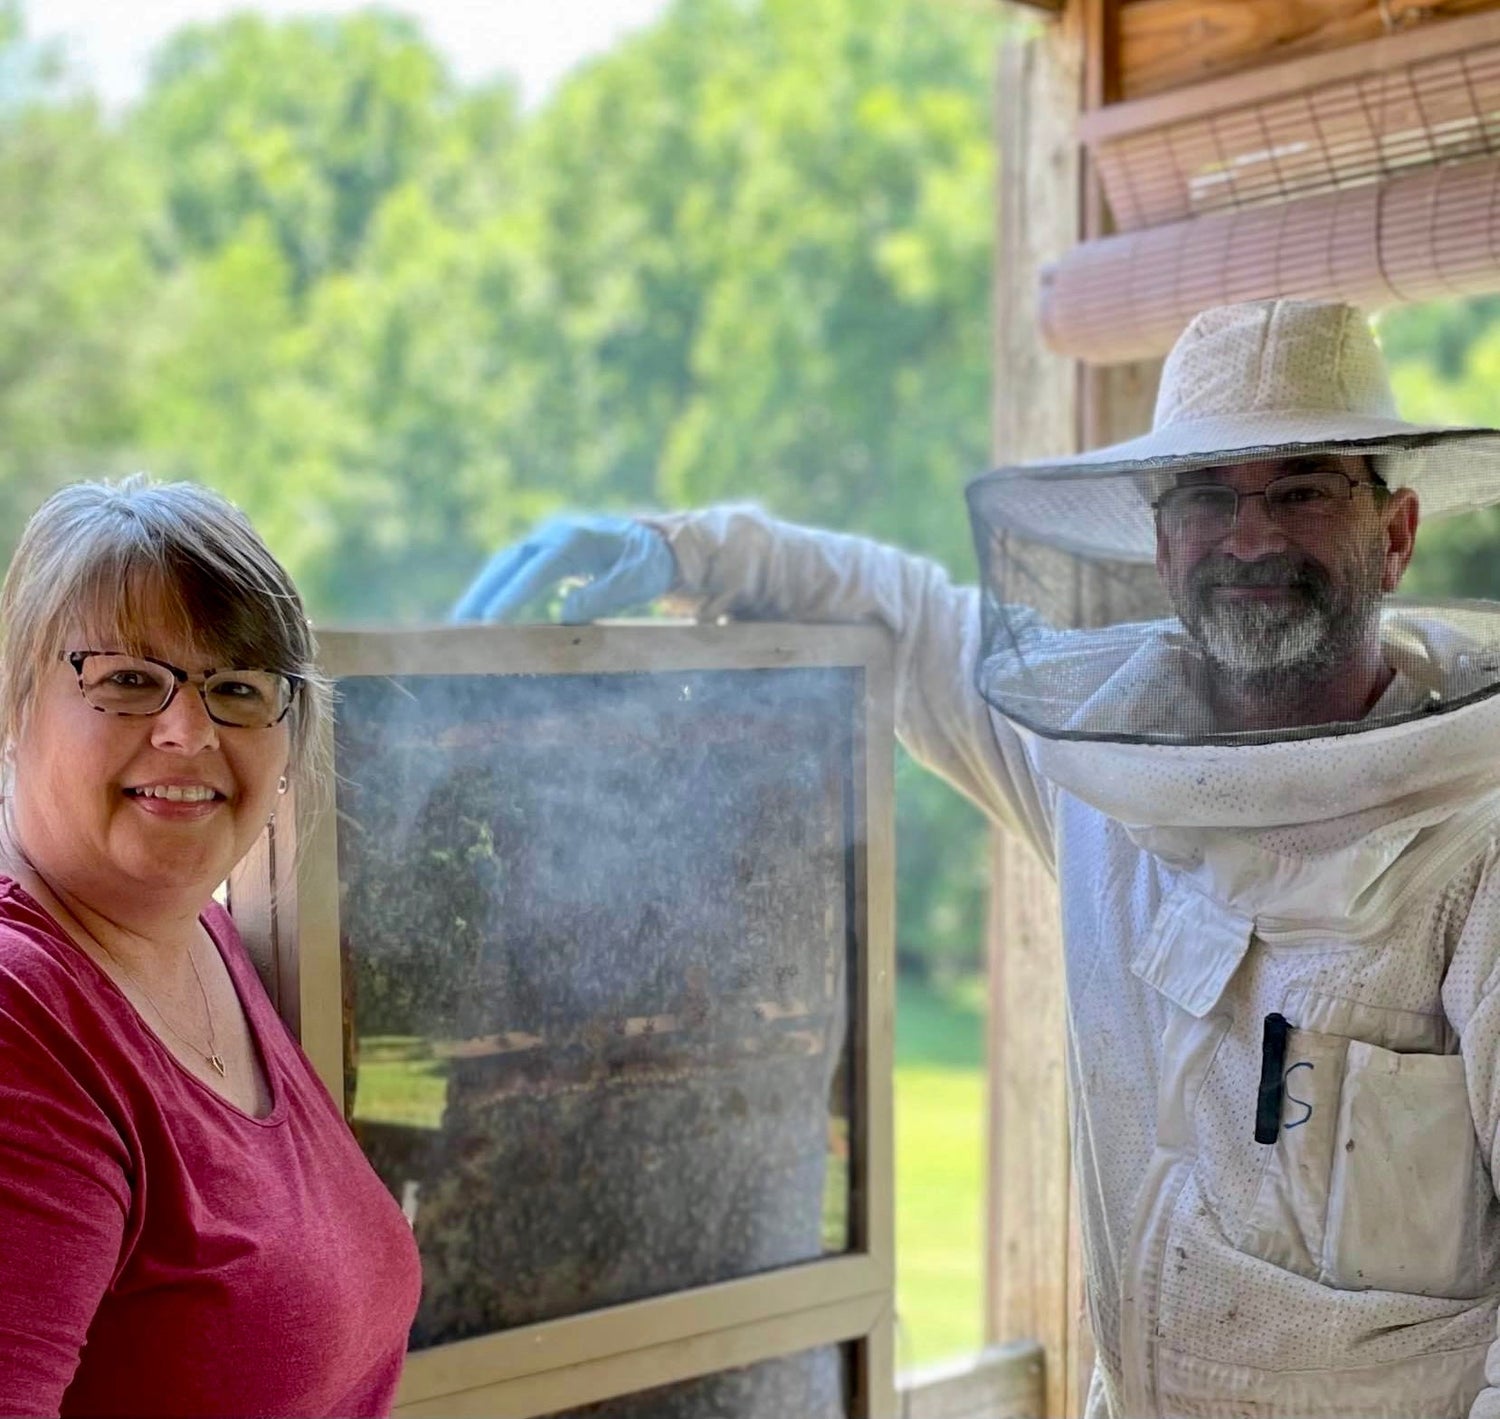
top-left (0, 0), bottom-right (1001, 977)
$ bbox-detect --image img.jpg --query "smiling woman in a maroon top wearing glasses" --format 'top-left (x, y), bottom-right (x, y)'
top-left (0, 479), bottom-right (420, 1416)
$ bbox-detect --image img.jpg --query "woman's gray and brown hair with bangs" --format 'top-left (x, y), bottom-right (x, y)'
top-left (0, 474), bottom-right (332, 797)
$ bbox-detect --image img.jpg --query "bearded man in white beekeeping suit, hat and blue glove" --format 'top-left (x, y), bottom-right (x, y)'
top-left (458, 292), bottom-right (1500, 1419)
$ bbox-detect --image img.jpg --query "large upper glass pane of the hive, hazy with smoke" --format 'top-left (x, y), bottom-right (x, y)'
top-left (336, 669), bottom-right (863, 1349)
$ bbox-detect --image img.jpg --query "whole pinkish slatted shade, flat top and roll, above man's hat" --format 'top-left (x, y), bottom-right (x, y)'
top-left (1041, 11), bottom-right (1500, 363)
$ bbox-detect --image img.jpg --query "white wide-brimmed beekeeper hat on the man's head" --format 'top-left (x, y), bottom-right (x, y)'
top-left (969, 300), bottom-right (1500, 561)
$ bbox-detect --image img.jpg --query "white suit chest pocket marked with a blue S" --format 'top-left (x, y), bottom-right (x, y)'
top-left (1239, 1029), bottom-right (1494, 1298)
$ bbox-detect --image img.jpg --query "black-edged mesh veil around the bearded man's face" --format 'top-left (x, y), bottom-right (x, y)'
top-left (969, 441), bottom-right (1500, 744)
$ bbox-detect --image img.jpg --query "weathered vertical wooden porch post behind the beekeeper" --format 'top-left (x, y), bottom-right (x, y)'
top-left (986, 0), bottom-right (1158, 1419)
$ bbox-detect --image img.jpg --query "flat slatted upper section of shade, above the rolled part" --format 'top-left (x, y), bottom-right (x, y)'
top-left (1085, 15), bottom-right (1500, 231)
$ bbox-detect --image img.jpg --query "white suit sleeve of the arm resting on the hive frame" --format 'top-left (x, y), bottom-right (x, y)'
top-left (645, 507), bottom-right (1053, 864)
